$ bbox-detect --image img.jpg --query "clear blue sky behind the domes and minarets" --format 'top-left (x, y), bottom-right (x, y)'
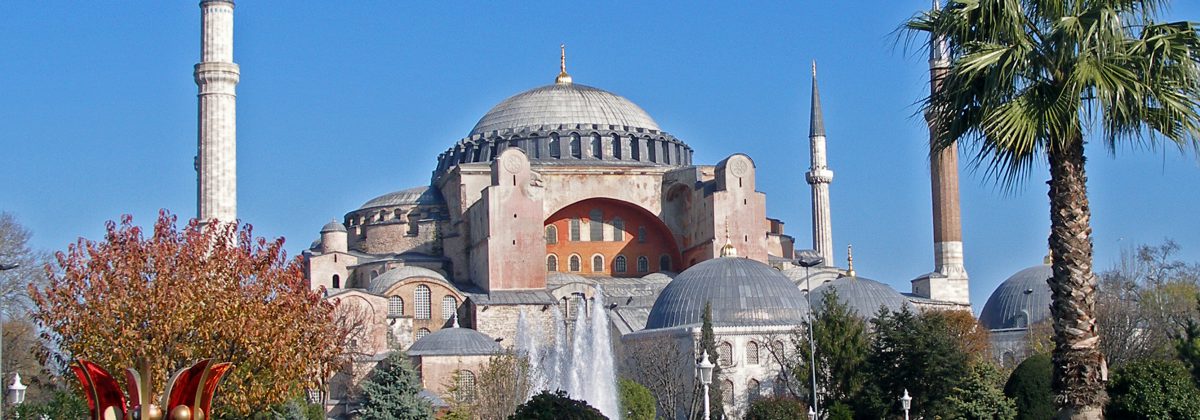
top-left (0, 0), bottom-right (1200, 311)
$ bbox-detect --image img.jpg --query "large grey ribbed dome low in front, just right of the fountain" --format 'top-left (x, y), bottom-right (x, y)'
top-left (646, 257), bottom-right (808, 330)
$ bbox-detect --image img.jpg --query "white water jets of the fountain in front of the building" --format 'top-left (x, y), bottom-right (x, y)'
top-left (516, 289), bottom-right (620, 419)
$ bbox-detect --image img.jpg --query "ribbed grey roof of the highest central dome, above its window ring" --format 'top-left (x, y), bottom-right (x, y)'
top-left (470, 83), bottom-right (659, 134)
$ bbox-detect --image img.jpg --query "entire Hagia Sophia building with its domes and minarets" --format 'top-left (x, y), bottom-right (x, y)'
top-left (184, 0), bottom-right (1049, 418)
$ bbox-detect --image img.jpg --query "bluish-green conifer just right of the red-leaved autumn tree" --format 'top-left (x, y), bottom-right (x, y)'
top-left (360, 352), bottom-right (433, 420)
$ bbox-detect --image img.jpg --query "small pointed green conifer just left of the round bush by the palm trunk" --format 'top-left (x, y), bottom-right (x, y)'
top-left (947, 360), bottom-right (1016, 420)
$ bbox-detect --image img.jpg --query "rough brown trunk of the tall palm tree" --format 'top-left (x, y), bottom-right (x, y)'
top-left (1048, 133), bottom-right (1108, 419)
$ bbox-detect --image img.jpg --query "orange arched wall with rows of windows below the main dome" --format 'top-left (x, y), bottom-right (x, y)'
top-left (544, 198), bottom-right (684, 277)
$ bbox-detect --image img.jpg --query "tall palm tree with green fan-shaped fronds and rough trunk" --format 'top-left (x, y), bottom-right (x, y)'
top-left (905, 0), bottom-right (1200, 419)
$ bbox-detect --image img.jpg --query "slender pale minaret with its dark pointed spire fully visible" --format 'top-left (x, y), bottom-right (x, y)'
top-left (804, 61), bottom-right (833, 265)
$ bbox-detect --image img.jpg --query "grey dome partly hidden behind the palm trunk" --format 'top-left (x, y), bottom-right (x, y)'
top-left (979, 264), bottom-right (1054, 330)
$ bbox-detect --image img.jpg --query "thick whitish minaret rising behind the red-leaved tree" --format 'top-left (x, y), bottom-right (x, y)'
top-left (194, 0), bottom-right (240, 222)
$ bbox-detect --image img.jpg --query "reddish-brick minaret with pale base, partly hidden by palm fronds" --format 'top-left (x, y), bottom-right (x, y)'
top-left (913, 0), bottom-right (971, 305)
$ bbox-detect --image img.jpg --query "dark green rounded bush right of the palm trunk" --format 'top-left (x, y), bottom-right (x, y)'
top-left (1108, 360), bottom-right (1200, 420)
